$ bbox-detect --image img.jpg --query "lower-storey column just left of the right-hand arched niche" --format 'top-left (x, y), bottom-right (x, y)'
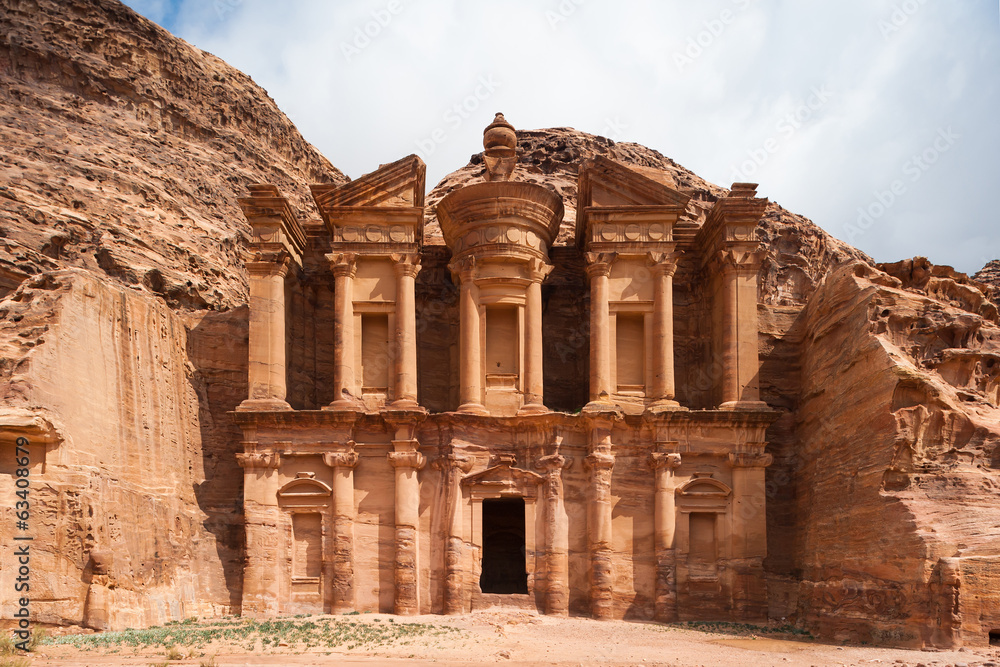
top-left (650, 443), bottom-right (681, 623)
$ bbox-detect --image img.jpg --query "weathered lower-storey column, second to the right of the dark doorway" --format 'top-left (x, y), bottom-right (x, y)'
top-left (584, 428), bottom-right (615, 620)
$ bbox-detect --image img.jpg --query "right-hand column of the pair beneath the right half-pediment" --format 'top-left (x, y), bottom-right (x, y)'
top-left (650, 253), bottom-right (679, 409)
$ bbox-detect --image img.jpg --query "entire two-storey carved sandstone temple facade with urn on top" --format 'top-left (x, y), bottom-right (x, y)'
top-left (232, 114), bottom-right (774, 621)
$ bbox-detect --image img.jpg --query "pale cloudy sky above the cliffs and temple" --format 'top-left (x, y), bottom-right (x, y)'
top-left (126, 0), bottom-right (1000, 273)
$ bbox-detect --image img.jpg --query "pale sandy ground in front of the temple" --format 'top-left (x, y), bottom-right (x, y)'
top-left (25, 610), bottom-right (1000, 667)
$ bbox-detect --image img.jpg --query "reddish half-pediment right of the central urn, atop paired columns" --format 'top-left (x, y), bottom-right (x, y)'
top-left (578, 155), bottom-right (690, 209)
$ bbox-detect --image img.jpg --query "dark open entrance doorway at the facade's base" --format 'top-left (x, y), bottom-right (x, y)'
top-left (479, 498), bottom-right (528, 594)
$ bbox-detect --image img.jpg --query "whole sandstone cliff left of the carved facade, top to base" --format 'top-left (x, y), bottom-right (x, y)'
top-left (0, 0), bottom-right (346, 627)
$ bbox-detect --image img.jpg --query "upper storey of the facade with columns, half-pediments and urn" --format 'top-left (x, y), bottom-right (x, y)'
top-left (239, 114), bottom-right (767, 417)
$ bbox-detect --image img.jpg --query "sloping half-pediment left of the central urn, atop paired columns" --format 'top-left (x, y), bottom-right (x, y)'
top-left (310, 155), bottom-right (427, 218)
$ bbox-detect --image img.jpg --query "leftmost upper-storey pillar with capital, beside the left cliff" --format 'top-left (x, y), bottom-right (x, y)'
top-left (237, 252), bottom-right (292, 410)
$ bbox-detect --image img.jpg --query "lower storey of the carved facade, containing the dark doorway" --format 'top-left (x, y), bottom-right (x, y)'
top-left (234, 406), bottom-right (772, 621)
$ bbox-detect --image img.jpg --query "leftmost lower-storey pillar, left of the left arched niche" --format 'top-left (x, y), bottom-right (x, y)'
top-left (236, 452), bottom-right (282, 616)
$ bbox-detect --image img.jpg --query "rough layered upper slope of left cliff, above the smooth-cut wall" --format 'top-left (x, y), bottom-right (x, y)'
top-left (0, 0), bottom-right (347, 308)
